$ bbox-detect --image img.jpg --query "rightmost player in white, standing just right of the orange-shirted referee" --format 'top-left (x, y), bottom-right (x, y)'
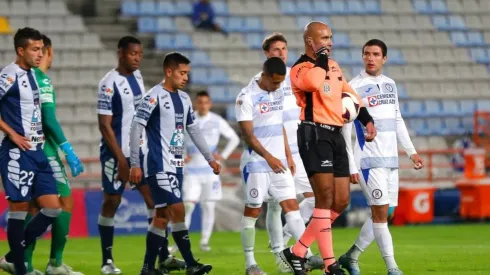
top-left (339, 39), bottom-right (423, 275)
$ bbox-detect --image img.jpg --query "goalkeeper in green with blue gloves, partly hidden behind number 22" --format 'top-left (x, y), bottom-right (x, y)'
top-left (25, 35), bottom-right (83, 275)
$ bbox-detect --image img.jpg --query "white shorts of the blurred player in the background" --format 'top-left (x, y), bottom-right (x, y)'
top-left (182, 174), bottom-right (222, 202)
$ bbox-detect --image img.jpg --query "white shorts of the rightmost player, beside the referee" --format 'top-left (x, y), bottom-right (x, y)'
top-left (359, 168), bottom-right (399, 206)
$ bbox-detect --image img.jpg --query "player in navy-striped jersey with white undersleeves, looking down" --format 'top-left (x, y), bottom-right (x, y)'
top-left (130, 52), bottom-right (221, 275)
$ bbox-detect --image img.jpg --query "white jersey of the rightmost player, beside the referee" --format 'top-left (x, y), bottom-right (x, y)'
top-left (344, 70), bottom-right (416, 174)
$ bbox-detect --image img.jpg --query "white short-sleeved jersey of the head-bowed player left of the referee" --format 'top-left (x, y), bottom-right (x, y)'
top-left (235, 80), bottom-right (287, 173)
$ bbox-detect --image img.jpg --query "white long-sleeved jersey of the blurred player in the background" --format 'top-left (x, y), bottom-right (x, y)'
top-left (185, 112), bottom-right (239, 175)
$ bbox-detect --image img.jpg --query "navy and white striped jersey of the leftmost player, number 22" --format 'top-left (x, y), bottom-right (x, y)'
top-left (0, 63), bottom-right (44, 150)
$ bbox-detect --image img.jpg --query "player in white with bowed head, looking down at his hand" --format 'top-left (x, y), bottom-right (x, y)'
top-left (235, 57), bottom-right (305, 275)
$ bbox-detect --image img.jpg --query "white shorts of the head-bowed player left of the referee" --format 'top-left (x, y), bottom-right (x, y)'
top-left (242, 170), bottom-right (296, 208)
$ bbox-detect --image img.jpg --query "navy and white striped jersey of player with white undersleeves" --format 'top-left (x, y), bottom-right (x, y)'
top-left (134, 84), bottom-right (195, 177)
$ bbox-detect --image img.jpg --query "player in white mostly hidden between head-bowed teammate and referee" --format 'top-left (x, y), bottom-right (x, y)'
top-left (251, 32), bottom-right (323, 272)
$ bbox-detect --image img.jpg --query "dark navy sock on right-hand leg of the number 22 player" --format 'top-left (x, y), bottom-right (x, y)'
top-left (25, 208), bottom-right (57, 246)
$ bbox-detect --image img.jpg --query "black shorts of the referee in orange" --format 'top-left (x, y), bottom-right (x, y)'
top-left (298, 122), bottom-right (350, 178)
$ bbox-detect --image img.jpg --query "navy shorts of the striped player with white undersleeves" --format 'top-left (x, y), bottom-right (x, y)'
top-left (146, 172), bottom-right (184, 208)
